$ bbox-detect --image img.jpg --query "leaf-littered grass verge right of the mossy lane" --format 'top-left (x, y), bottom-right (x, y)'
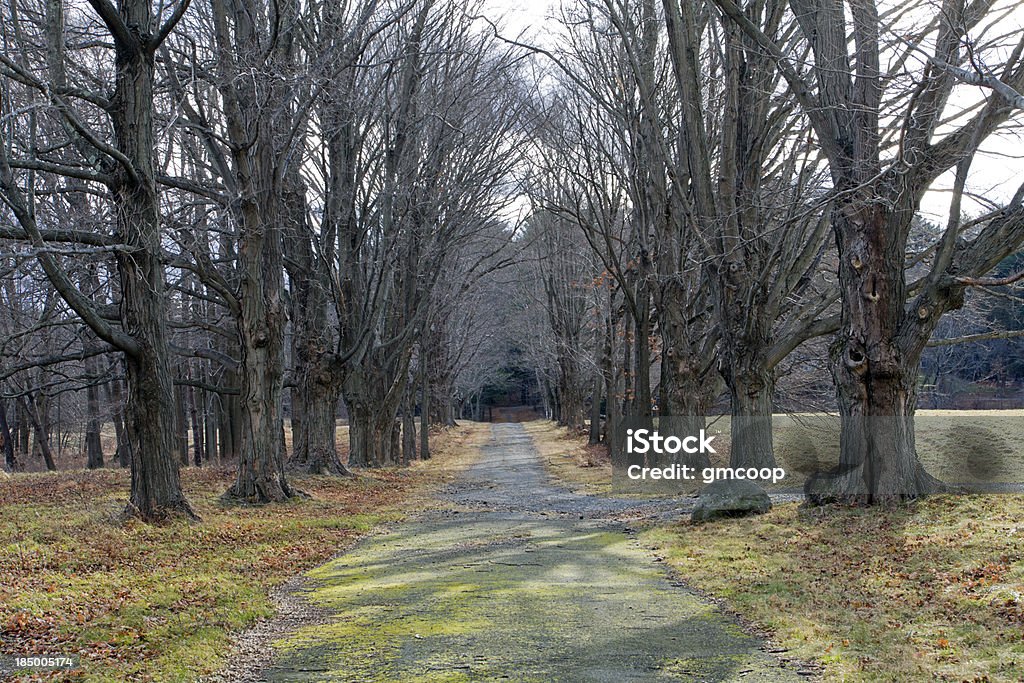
top-left (530, 423), bottom-right (1024, 681)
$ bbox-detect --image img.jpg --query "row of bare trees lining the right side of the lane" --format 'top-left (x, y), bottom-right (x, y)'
top-left (528, 0), bottom-right (1024, 502)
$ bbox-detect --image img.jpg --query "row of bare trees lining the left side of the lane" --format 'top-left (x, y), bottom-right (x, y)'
top-left (0, 0), bottom-right (526, 520)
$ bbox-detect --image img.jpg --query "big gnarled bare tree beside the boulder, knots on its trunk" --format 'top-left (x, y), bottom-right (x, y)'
top-left (715, 0), bottom-right (1024, 503)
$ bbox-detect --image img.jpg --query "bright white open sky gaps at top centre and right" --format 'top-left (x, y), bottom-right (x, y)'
top-left (484, 0), bottom-right (1024, 224)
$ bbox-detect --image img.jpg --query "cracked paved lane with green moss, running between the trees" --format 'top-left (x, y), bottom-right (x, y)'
top-left (251, 424), bottom-right (806, 682)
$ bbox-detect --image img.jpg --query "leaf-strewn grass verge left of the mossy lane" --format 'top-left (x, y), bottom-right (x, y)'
top-left (0, 423), bottom-right (487, 681)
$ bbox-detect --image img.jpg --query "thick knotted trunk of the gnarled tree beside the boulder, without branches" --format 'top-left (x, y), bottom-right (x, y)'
top-left (809, 204), bottom-right (938, 504)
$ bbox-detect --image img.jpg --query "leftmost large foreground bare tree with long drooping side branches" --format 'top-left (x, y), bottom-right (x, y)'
top-left (0, 0), bottom-right (193, 520)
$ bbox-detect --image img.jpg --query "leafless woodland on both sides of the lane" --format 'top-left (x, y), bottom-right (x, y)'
top-left (0, 0), bottom-right (1024, 680)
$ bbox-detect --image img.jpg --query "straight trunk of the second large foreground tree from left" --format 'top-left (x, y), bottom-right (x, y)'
top-left (212, 0), bottom-right (298, 504)
